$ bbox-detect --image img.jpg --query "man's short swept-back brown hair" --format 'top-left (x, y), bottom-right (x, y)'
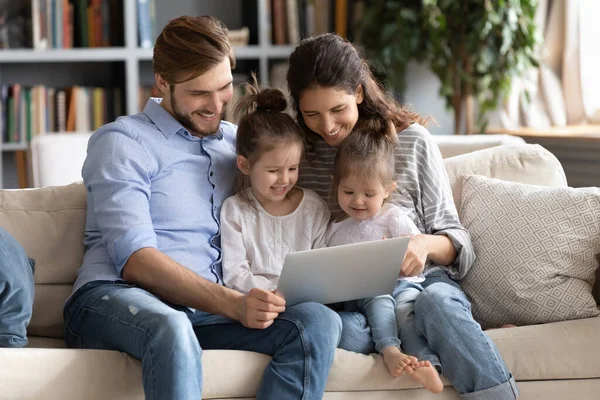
top-left (152, 16), bottom-right (235, 85)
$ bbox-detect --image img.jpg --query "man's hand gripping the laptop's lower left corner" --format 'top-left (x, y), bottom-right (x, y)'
top-left (237, 288), bottom-right (285, 329)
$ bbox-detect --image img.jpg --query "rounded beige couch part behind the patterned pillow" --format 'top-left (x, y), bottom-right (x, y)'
top-left (444, 144), bottom-right (567, 212)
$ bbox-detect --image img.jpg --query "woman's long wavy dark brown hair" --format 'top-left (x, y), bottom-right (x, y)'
top-left (287, 33), bottom-right (427, 147)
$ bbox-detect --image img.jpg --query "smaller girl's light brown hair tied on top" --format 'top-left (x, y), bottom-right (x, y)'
top-left (330, 119), bottom-right (398, 204)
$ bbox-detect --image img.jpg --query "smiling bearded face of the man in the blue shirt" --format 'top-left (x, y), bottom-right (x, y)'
top-left (156, 58), bottom-right (233, 137)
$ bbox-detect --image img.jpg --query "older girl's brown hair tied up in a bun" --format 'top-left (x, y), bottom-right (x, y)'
top-left (234, 74), bottom-right (303, 203)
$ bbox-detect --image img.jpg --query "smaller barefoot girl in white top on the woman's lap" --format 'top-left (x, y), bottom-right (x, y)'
top-left (326, 120), bottom-right (443, 393)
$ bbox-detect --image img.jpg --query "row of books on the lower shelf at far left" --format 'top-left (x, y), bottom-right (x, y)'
top-left (0, 84), bottom-right (124, 143)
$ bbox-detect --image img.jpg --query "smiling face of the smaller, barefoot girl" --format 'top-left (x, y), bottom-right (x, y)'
top-left (337, 175), bottom-right (394, 221)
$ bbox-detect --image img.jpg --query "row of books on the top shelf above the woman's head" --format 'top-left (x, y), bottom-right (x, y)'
top-left (267, 0), bottom-right (366, 45)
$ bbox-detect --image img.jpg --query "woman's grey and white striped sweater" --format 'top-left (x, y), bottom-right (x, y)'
top-left (298, 124), bottom-right (475, 279)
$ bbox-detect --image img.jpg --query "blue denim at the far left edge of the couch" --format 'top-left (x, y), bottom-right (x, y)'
top-left (0, 228), bottom-right (35, 347)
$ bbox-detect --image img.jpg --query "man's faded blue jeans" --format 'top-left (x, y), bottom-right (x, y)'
top-left (64, 281), bottom-right (342, 400)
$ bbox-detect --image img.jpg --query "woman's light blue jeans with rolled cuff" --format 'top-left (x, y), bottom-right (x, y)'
top-left (340, 271), bottom-right (518, 400)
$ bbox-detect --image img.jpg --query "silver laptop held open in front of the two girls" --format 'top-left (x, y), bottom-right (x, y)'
top-left (277, 237), bottom-right (410, 306)
